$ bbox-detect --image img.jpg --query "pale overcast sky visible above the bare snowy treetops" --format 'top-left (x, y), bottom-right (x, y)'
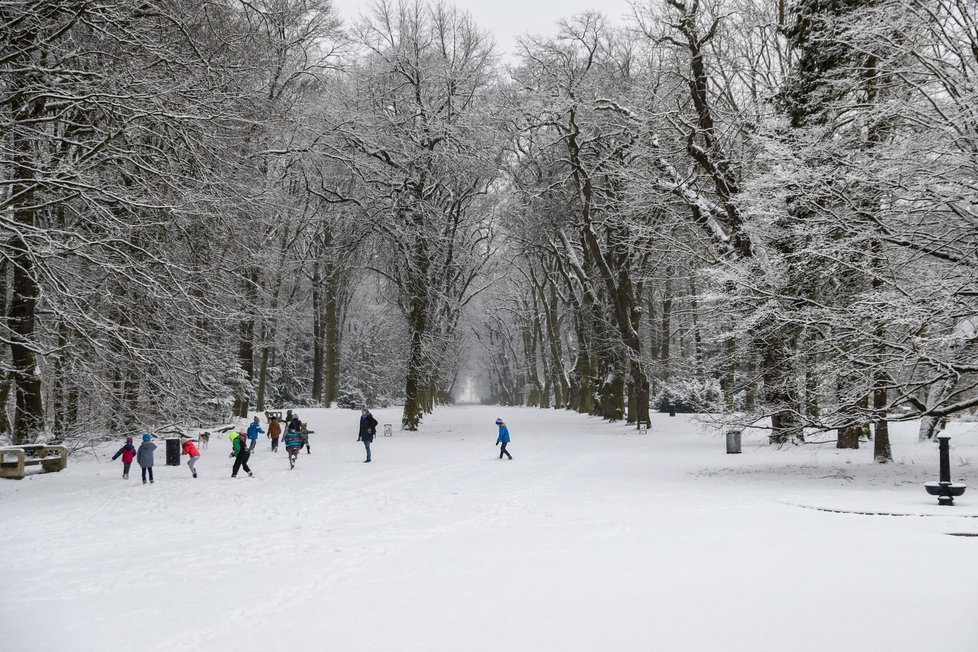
top-left (334, 0), bottom-right (629, 55)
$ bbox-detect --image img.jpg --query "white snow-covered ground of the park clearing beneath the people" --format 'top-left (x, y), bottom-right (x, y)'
top-left (0, 407), bottom-right (978, 652)
